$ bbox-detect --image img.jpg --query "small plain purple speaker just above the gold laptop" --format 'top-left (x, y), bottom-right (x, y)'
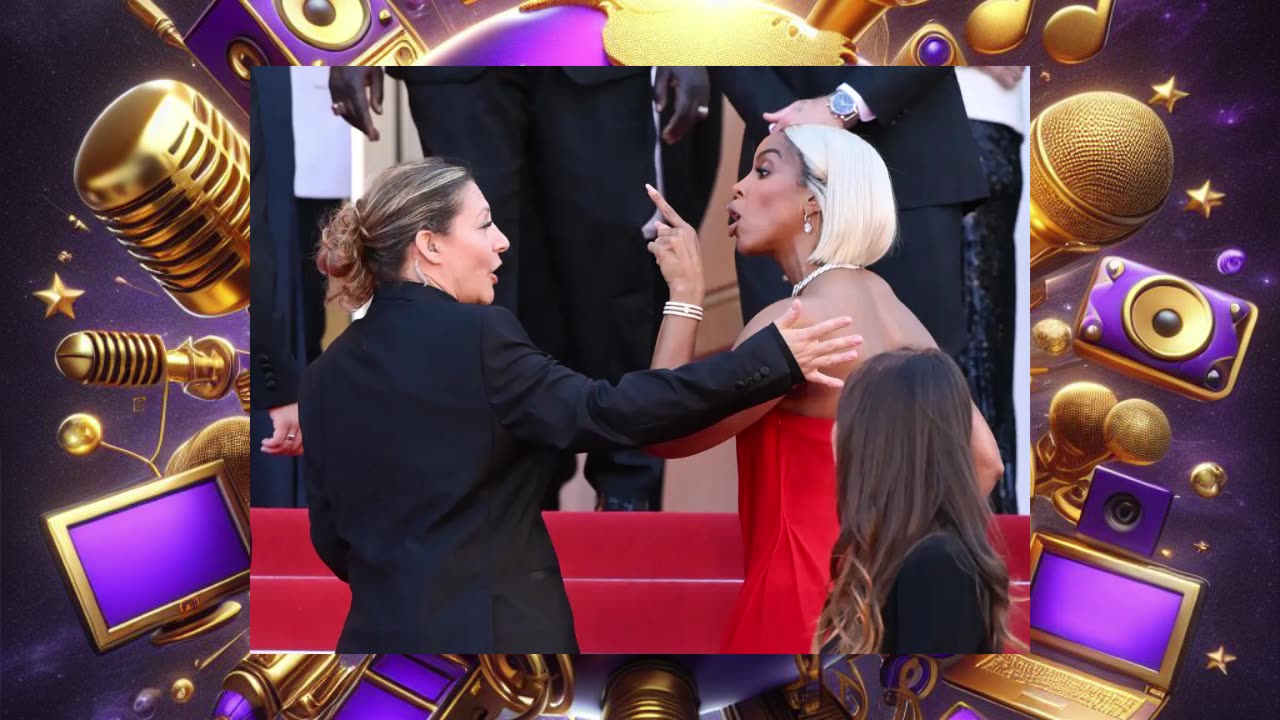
top-left (1075, 465), bottom-right (1174, 556)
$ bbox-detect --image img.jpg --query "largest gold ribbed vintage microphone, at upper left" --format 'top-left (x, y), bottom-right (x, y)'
top-left (74, 79), bottom-right (250, 318)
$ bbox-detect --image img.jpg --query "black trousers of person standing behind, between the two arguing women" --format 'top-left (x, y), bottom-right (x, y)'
top-left (407, 68), bottom-right (666, 509)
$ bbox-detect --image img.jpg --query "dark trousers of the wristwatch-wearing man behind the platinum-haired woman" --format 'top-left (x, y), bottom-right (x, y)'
top-left (735, 205), bottom-right (969, 357)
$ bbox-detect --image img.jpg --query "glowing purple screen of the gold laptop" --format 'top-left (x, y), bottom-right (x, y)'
top-left (1030, 550), bottom-right (1183, 673)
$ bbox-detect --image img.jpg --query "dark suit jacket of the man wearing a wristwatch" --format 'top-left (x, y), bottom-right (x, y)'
top-left (713, 67), bottom-right (988, 211)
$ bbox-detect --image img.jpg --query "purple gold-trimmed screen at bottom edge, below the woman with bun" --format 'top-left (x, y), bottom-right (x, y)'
top-left (333, 655), bottom-right (467, 720)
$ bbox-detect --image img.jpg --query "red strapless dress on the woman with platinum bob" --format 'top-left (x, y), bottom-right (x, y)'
top-left (721, 409), bottom-right (838, 653)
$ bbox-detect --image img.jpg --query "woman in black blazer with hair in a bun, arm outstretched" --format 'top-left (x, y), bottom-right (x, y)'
top-left (300, 158), bottom-right (855, 653)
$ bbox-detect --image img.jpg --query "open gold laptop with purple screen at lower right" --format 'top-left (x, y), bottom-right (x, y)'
top-left (945, 533), bottom-right (1208, 720)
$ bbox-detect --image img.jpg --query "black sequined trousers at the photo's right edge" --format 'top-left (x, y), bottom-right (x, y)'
top-left (959, 120), bottom-right (1023, 512)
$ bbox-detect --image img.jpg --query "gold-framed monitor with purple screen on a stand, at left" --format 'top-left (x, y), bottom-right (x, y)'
top-left (44, 460), bottom-right (250, 651)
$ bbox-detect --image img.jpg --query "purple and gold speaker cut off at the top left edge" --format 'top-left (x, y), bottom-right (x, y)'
top-left (183, 0), bottom-right (426, 109)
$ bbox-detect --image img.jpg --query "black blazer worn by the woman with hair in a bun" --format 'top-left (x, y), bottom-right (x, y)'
top-left (300, 282), bottom-right (804, 652)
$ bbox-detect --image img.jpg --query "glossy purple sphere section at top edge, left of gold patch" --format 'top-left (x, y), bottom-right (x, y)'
top-left (422, 5), bottom-right (611, 65)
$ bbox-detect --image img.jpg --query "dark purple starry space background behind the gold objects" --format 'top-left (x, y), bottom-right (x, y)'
top-left (0, 0), bottom-right (1280, 720)
